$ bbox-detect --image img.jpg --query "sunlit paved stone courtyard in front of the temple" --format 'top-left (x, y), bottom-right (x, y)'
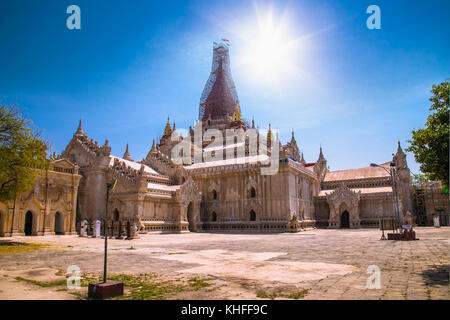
top-left (0, 227), bottom-right (450, 299)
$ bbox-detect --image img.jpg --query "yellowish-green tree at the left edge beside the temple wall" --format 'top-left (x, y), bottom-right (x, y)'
top-left (0, 105), bottom-right (47, 201)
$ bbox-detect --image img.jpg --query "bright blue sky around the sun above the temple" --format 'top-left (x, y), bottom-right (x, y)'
top-left (0, 0), bottom-right (450, 172)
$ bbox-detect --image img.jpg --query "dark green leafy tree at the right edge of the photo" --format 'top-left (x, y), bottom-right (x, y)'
top-left (406, 80), bottom-right (450, 189)
